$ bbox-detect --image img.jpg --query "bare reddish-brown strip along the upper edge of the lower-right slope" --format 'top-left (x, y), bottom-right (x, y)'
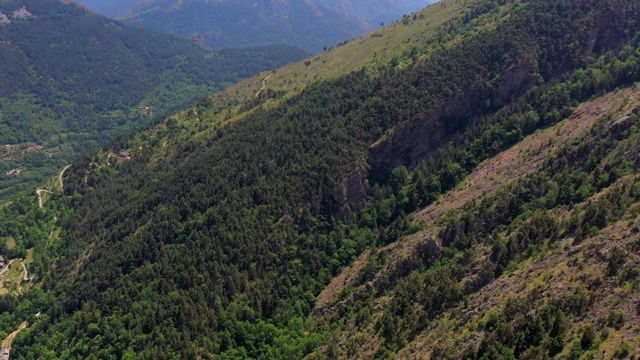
top-left (315, 88), bottom-right (640, 311)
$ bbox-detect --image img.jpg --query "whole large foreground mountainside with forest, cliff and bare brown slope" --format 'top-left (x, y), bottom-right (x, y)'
top-left (0, 0), bottom-right (640, 359)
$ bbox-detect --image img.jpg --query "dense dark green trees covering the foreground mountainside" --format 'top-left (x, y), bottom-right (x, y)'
top-left (3, 0), bottom-right (640, 359)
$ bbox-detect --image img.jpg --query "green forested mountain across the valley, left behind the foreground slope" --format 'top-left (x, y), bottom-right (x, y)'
top-left (0, 0), bottom-right (306, 196)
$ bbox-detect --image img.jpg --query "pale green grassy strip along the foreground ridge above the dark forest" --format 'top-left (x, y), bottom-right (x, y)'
top-left (184, 0), bottom-right (476, 126)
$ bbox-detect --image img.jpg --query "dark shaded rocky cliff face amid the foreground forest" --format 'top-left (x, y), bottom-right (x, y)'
top-left (369, 14), bottom-right (625, 178)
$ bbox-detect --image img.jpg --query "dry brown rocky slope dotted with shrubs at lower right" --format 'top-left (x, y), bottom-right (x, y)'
top-left (314, 88), bottom-right (640, 358)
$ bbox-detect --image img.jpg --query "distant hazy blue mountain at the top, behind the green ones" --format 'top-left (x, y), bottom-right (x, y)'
top-left (75, 0), bottom-right (436, 52)
